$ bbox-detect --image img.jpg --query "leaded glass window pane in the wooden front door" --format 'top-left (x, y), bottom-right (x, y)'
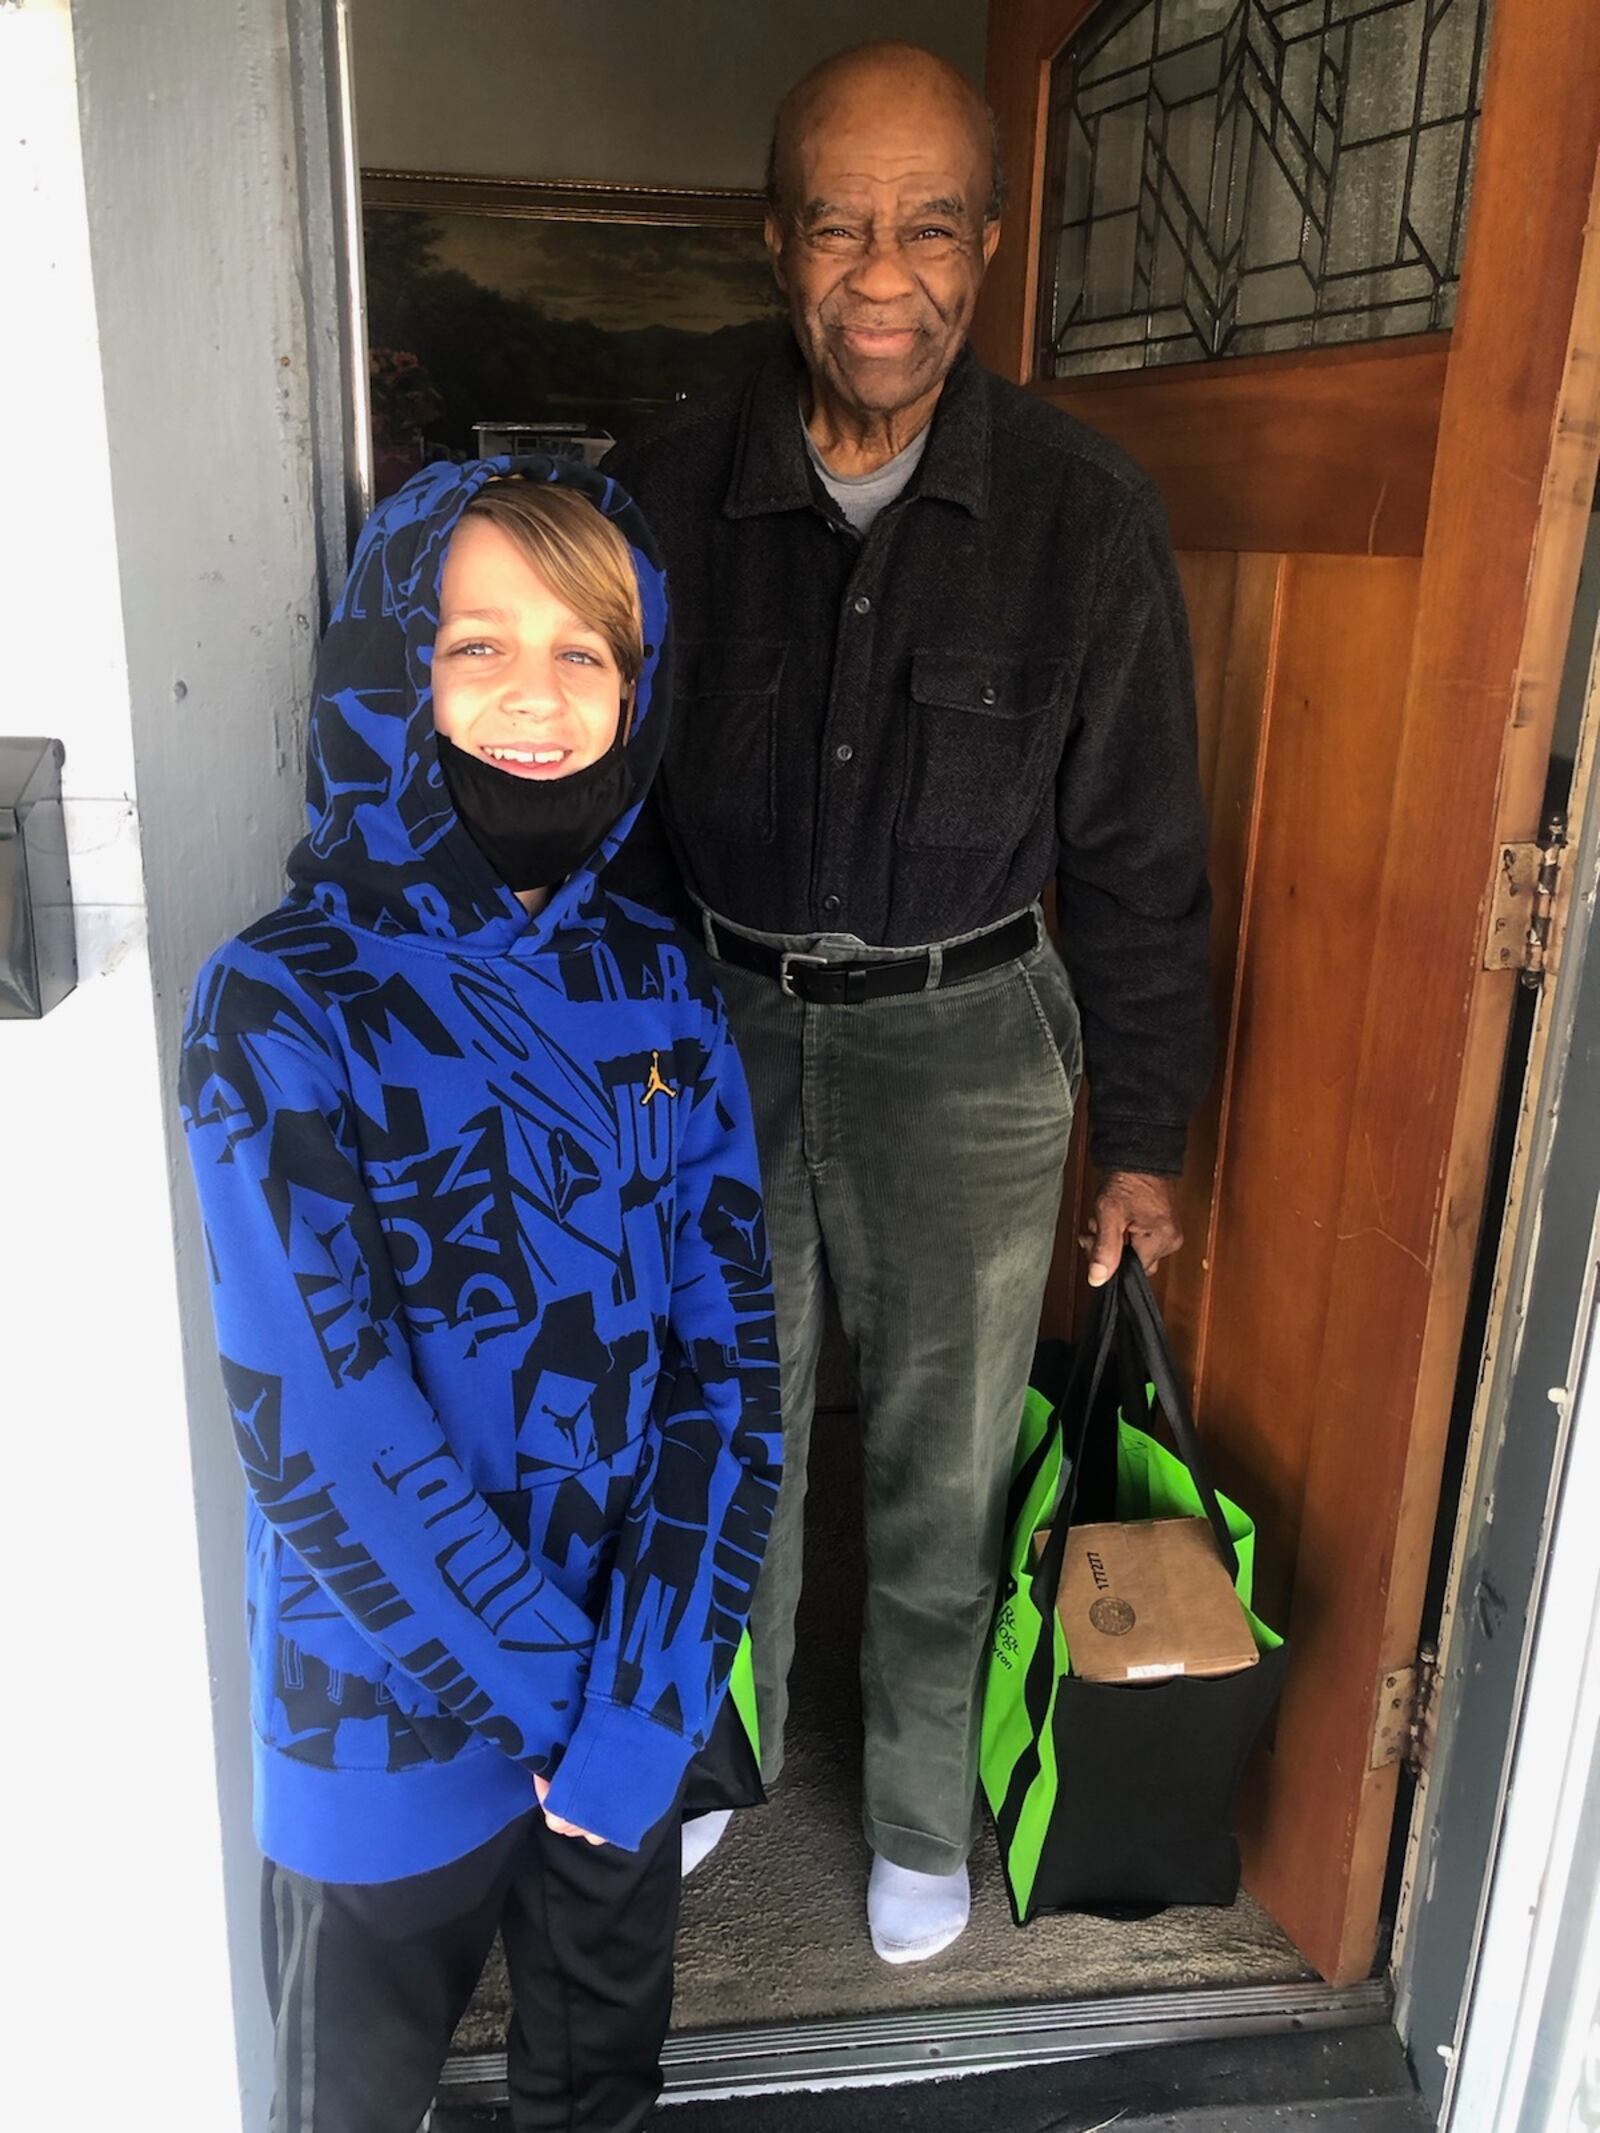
top-left (1039, 0), bottom-right (1489, 378)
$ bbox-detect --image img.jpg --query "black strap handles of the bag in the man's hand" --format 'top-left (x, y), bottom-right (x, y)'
top-left (1033, 1248), bottom-right (1239, 1621)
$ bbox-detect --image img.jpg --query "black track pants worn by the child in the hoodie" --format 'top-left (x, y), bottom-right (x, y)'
top-left (262, 1815), bottom-right (681, 2133)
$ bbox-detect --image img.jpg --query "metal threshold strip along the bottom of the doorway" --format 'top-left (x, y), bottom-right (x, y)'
top-left (439, 1979), bottom-right (1389, 2107)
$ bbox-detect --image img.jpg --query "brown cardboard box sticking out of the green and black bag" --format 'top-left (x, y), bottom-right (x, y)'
top-left (1035, 1519), bottom-right (1259, 1681)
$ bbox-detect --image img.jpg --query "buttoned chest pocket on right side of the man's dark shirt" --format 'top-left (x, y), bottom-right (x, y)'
top-left (894, 651), bottom-right (1067, 851)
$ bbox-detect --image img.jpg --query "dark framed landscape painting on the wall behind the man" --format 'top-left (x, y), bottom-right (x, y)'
top-left (361, 171), bottom-right (783, 497)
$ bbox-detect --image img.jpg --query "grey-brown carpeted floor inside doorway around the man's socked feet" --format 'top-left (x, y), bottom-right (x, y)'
top-left (454, 1412), bottom-right (1314, 2054)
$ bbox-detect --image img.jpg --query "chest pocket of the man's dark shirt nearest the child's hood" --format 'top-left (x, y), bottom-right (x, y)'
top-left (668, 638), bottom-right (789, 845)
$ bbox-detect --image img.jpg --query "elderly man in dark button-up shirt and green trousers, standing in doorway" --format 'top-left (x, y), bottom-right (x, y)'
top-left (610, 45), bottom-right (1210, 1962)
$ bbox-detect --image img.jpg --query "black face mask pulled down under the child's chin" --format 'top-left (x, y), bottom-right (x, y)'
top-left (435, 717), bottom-right (634, 889)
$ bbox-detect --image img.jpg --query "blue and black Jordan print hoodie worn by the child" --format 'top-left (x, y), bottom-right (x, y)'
top-left (181, 461), bottom-right (779, 1881)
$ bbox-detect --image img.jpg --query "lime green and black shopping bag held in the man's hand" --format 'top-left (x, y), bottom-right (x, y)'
top-left (979, 1252), bottom-right (1286, 1924)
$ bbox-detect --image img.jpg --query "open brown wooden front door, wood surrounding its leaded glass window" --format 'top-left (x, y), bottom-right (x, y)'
top-left (975, 0), bottom-right (1600, 1982)
